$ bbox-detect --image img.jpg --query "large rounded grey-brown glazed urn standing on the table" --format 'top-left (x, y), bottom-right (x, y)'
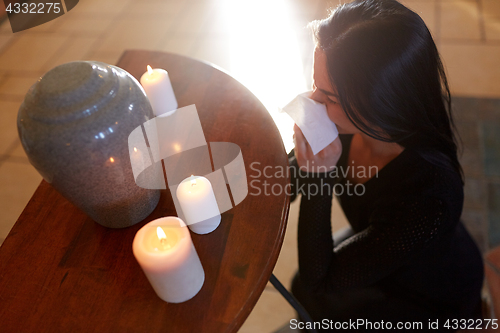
top-left (17, 61), bottom-right (160, 228)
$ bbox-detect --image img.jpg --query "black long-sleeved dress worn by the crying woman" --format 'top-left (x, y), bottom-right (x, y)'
top-left (291, 135), bottom-right (483, 332)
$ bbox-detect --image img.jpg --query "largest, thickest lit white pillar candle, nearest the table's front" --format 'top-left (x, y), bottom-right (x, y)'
top-left (132, 216), bottom-right (205, 303)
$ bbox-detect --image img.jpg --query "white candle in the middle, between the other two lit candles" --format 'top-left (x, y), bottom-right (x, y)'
top-left (176, 176), bottom-right (221, 234)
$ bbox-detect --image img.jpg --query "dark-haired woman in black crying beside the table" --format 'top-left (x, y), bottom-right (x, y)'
top-left (291, 0), bottom-right (483, 332)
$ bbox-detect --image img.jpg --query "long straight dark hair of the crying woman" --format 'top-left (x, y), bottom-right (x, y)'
top-left (312, 0), bottom-right (463, 180)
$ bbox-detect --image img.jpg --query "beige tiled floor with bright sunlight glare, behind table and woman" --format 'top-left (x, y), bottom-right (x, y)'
top-left (0, 0), bottom-right (500, 332)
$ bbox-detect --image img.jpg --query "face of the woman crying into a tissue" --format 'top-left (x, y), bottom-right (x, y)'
top-left (311, 47), bottom-right (360, 134)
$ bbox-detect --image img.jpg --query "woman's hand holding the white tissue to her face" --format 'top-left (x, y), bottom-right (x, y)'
top-left (293, 125), bottom-right (342, 173)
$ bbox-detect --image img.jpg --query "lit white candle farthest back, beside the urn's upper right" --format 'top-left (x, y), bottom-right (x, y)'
top-left (141, 65), bottom-right (178, 116)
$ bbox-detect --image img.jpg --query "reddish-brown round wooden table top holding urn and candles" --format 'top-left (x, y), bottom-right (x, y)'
top-left (0, 50), bottom-right (289, 332)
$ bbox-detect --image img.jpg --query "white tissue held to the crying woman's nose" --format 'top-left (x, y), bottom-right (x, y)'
top-left (282, 91), bottom-right (339, 155)
